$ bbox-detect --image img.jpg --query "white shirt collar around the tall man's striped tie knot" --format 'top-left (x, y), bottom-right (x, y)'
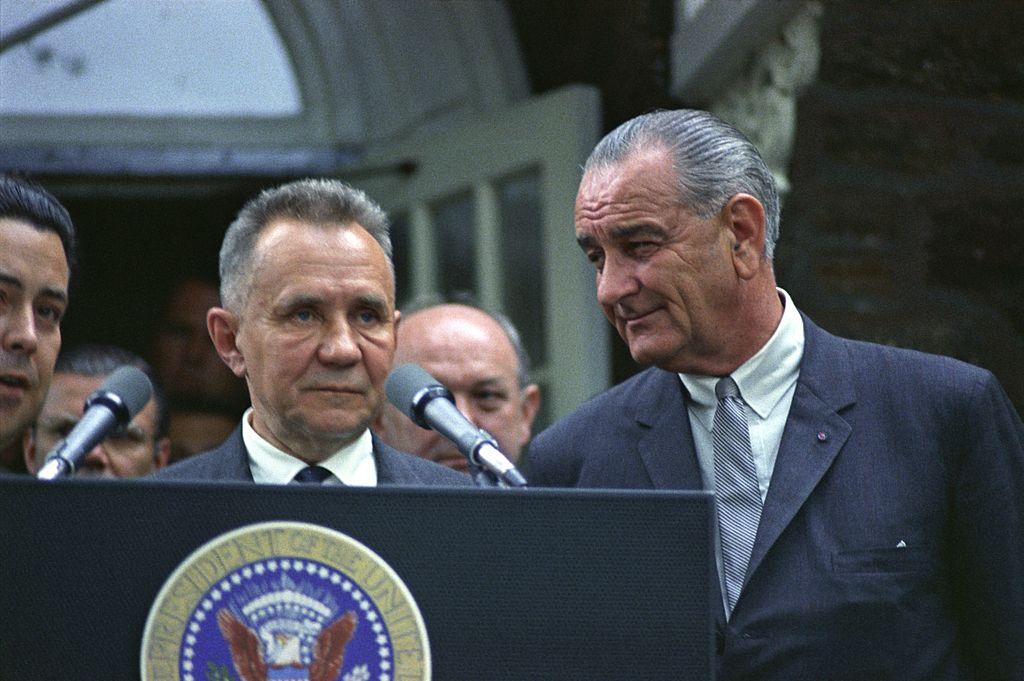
top-left (679, 289), bottom-right (804, 430)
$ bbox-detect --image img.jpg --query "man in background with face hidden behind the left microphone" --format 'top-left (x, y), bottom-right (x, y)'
top-left (23, 345), bottom-right (171, 478)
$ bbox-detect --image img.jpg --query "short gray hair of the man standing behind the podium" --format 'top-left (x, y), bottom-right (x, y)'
top-left (220, 179), bottom-right (394, 313)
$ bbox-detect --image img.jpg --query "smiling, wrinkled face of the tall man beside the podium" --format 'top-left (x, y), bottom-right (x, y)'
top-left (574, 148), bottom-right (739, 374)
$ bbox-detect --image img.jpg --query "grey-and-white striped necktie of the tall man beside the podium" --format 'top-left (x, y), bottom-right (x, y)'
top-left (712, 376), bottom-right (761, 614)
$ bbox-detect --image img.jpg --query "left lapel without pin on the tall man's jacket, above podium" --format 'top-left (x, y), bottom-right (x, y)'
top-left (636, 369), bottom-right (703, 490)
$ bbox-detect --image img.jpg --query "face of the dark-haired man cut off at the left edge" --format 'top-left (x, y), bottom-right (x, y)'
top-left (0, 218), bottom-right (69, 452)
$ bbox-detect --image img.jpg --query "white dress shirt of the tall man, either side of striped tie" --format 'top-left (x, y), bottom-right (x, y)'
top-left (679, 289), bottom-right (804, 611)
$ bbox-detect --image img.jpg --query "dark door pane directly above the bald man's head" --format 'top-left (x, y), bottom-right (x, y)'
top-left (431, 194), bottom-right (476, 295)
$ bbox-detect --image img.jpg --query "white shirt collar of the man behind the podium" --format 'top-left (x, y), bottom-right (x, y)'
top-left (242, 408), bottom-right (377, 486)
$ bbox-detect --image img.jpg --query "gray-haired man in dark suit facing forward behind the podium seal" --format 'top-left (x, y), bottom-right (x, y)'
top-left (156, 180), bottom-right (471, 486)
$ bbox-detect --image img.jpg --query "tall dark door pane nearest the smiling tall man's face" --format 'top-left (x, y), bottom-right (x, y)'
top-left (498, 170), bottom-right (547, 365)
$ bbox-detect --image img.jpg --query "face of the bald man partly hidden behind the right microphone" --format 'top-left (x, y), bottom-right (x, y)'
top-left (380, 305), bottom-right (540, 470)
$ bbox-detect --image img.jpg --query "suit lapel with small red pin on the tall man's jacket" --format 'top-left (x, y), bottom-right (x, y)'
top-left (746, 316), bottom-right (856, 580)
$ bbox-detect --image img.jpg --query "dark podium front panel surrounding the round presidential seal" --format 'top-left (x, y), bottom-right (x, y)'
top-left (0, 478), bottom-right (715, 681)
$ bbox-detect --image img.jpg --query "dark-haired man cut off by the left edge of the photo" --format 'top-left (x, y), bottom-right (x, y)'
top-left (0, 174), bottom-right (75, 473)
